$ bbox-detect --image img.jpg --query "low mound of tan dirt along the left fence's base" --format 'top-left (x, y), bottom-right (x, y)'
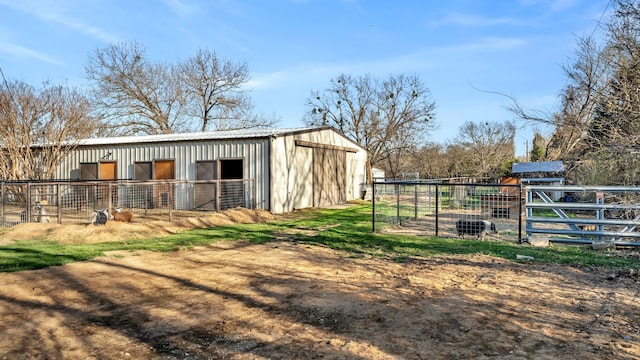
top-left (0, 208), bottom-right (275, 244)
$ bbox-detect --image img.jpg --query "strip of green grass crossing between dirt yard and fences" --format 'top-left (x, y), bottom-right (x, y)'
top-left (0, 204), bottom-right (638, 272)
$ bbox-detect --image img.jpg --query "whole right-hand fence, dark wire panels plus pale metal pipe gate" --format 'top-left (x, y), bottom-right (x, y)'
top-left (372, 180), bottom-right (640, 247)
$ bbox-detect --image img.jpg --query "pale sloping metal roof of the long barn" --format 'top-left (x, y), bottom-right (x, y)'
top-left (78, 126), bottom-right (331, 146)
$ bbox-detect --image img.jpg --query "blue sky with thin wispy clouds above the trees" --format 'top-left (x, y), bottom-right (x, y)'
top-left (0, 0), bottom-right (611, 155)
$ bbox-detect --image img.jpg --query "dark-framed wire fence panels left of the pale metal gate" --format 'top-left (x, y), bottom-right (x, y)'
top-left (372, 180), bottom-right (524, 241)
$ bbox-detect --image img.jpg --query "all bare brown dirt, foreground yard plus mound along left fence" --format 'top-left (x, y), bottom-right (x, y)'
top-left (0, 210), bottom-right (640, 359)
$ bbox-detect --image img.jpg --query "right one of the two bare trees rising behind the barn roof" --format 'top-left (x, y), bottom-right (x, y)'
top-left (177, 49), bottom-right (278, 131)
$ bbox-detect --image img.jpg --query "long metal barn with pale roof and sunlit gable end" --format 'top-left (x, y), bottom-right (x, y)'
top-left (56, 127), bottom-right (367, 214)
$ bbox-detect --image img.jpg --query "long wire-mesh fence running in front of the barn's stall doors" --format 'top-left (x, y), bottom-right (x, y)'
top-left (0, 179), bottom-right (256, 227)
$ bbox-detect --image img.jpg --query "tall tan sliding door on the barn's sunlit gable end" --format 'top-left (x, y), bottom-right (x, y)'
top-left (313, 147), bottom-right (347, 207)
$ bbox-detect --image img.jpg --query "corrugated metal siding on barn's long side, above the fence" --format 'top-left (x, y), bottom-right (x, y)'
top-left (56, 139), bottom-right (269, 210)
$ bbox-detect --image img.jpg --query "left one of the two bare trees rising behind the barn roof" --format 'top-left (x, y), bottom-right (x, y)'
top-left (85, 42), bottom-right (188, 134)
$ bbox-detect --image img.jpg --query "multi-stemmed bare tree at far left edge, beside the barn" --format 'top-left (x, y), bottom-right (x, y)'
top-left (0, 80), bottom-right (98, 180)
